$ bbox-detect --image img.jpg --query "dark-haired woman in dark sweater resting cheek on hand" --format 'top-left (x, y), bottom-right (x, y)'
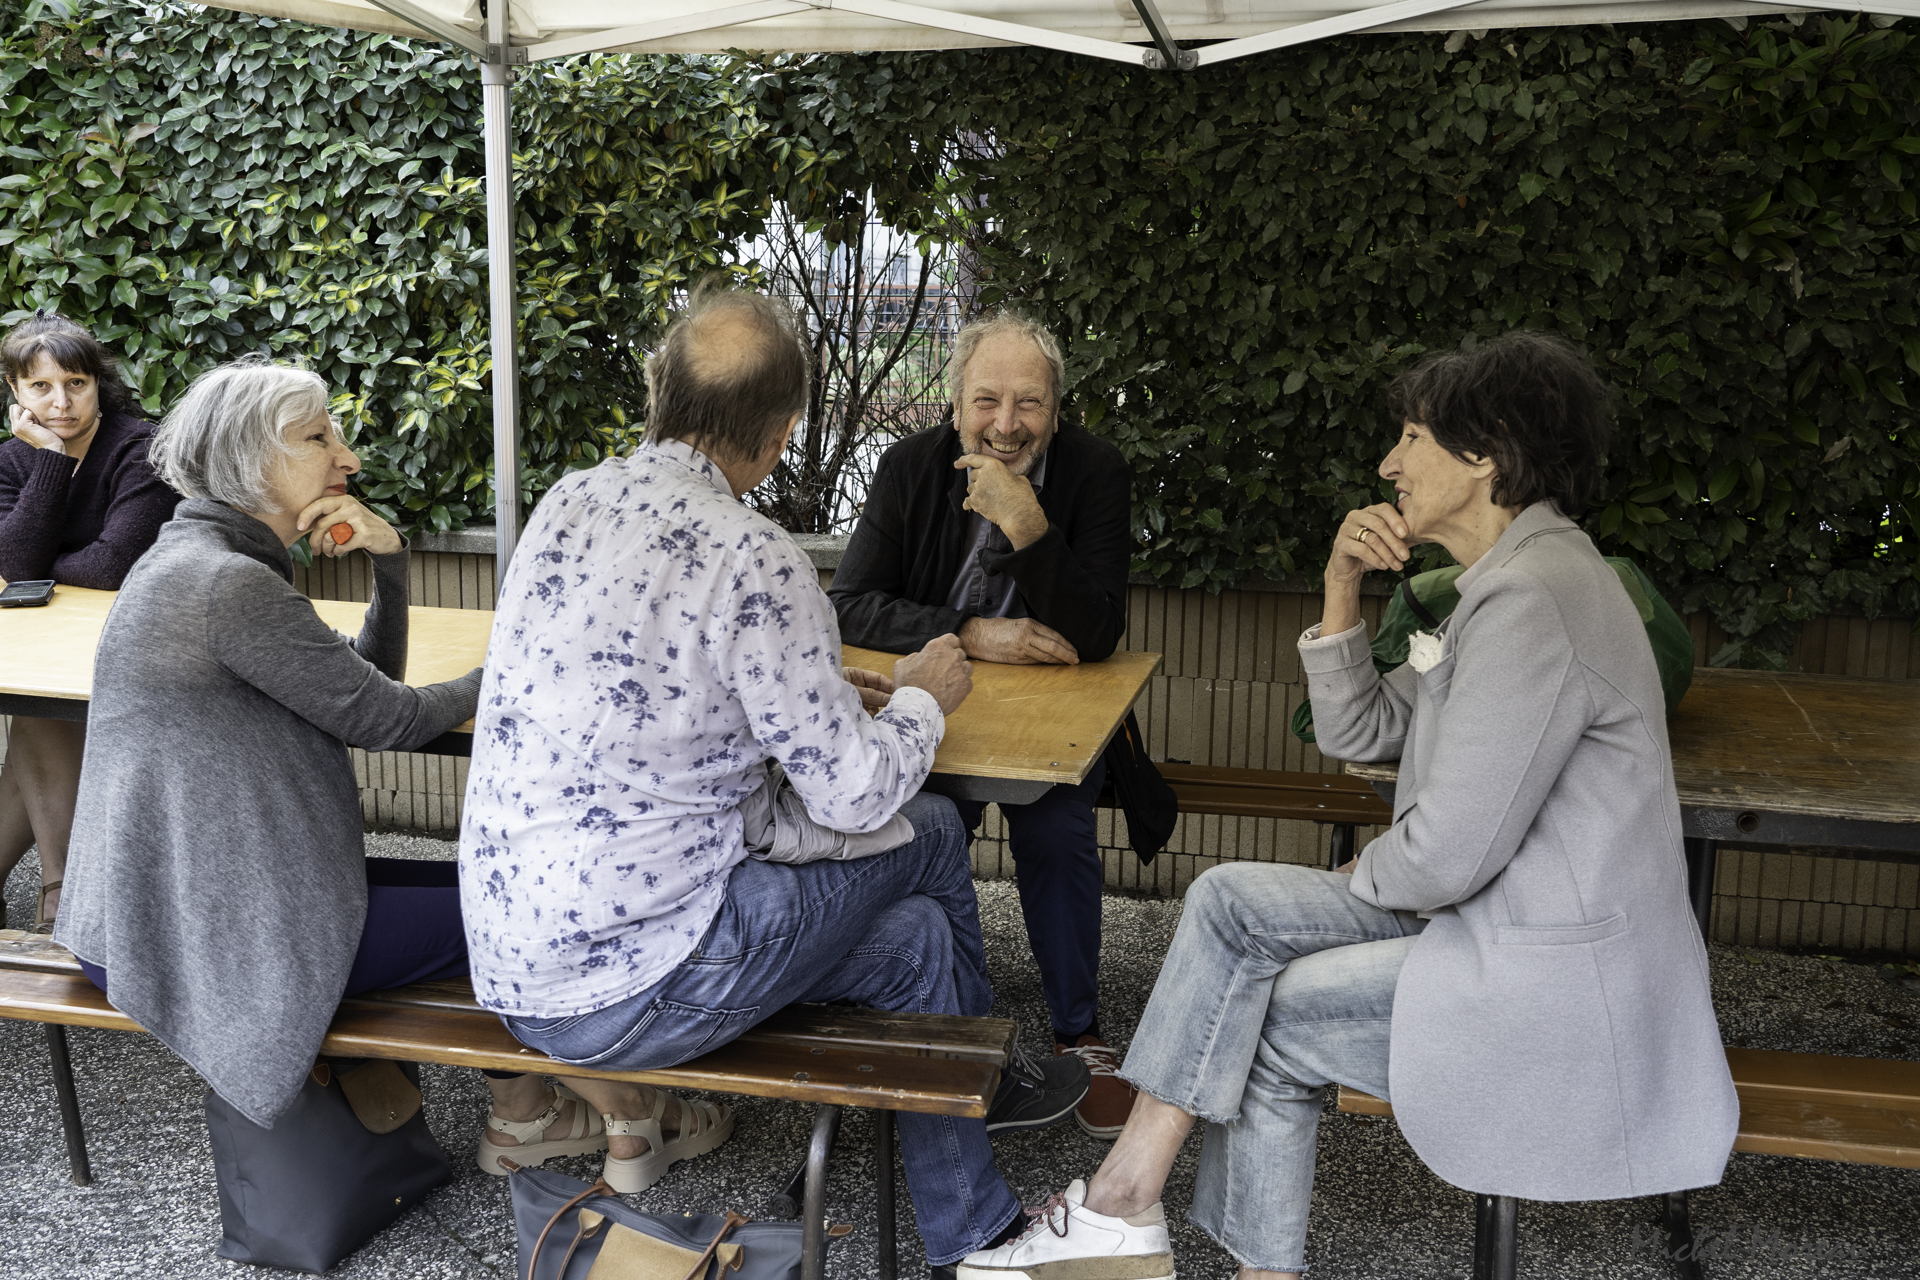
top-left (0, 311), bottom-right (180, 929)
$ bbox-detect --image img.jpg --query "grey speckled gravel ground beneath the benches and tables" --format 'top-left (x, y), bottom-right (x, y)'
top-left (0, 835), bottom-right (1920, 1280)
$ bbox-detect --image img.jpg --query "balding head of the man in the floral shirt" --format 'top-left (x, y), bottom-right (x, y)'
top-left (647, 282), bottom-right (810, 461)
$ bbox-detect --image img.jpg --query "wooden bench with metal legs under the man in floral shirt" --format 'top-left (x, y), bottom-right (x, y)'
top-left (0, 931), bottom-right (1016, 1280)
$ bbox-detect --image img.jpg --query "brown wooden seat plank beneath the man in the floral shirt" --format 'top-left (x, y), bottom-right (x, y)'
top-left (0, 965), bottom-right (1012, 1119)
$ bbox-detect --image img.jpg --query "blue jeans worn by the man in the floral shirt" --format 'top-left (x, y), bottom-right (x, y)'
top-left (501, 794), bottom-right (1020, 1265)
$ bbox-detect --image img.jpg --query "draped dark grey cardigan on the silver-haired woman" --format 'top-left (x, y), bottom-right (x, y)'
top-left (54, 499), bottom-right (480, 1125)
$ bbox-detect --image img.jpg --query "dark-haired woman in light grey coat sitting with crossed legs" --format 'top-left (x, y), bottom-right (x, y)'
top-left (958, 332), bottom-right (1740, 1280)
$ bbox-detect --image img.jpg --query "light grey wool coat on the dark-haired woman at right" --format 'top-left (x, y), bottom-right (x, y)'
top-left (1302, 503), bottom-right (1740, 1199)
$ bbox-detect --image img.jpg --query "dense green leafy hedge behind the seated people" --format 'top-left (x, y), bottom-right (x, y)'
top-left (0, 10), bottom-right (1920, 660)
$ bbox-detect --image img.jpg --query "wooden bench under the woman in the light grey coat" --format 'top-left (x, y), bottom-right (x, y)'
top-left (1338, 1046), bottom-right (1920, 1278)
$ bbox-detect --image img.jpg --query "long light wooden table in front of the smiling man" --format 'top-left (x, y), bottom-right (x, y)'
top-left (0, 587), bottom-right (1160, 804)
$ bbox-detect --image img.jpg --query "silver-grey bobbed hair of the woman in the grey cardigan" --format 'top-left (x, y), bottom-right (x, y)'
top-left (148, 359), bottom-right (326, 510)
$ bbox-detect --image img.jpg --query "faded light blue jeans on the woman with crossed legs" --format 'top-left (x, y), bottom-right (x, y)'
top-left (1121, 864), bottom-right (1425, 1270)
